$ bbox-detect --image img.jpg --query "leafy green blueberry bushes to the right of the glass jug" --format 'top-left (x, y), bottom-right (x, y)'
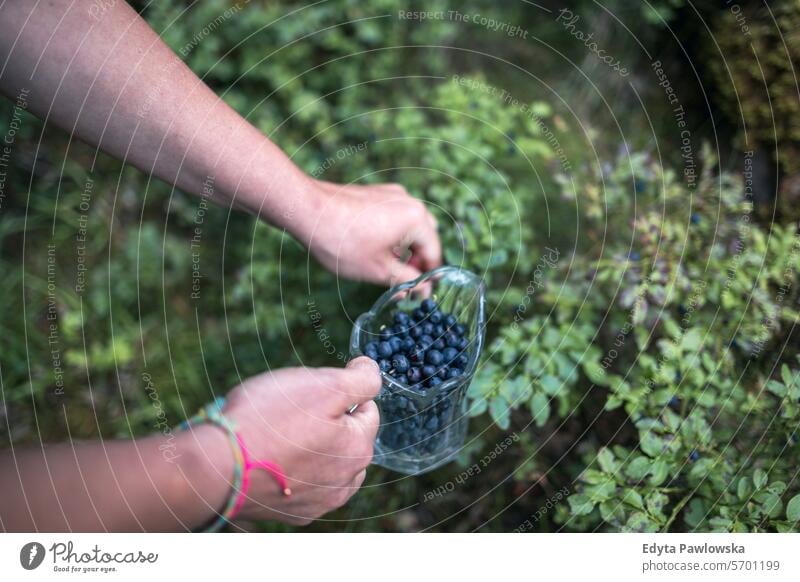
top-left (471, 146), bottom-right (800, 531)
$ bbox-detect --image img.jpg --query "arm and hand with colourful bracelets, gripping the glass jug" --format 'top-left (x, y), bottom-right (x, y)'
top-left (0, 358), bottom-right (380, 531)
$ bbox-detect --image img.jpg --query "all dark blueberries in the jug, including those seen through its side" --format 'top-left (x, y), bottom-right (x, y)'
top-left (364, 299), bottom-right (470, 456)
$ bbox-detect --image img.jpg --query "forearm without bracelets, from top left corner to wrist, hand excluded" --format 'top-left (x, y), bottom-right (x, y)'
top-left (0, 0), bottom-right (318, 240)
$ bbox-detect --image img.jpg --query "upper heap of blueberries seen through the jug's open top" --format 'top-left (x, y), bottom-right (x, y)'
top-left (364, 299), bottom-right (469, 391)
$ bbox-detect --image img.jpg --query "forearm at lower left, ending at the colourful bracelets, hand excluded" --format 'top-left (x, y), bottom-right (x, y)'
top-left (0, 425), bottom-right (233, 531)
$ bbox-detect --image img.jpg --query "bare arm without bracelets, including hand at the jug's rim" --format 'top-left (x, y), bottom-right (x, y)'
top-left (0, 0), bottom-right (441, 283)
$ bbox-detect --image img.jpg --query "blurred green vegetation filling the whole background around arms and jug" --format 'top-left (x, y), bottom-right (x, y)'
top-left (0, 0), bottom-right (800, 531)
